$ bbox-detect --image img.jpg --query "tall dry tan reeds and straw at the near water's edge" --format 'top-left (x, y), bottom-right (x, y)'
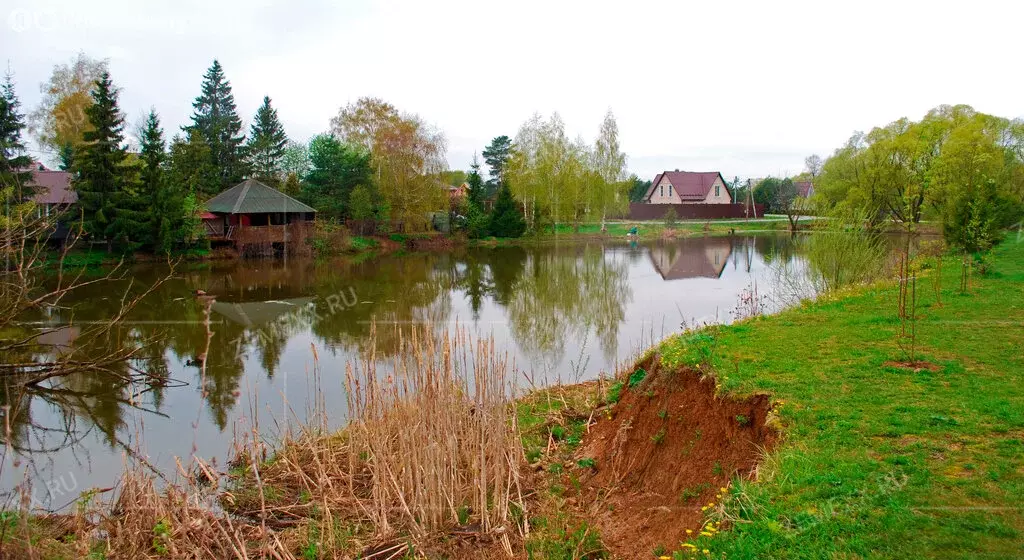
top-left (223, 328), bottom-right (525, 557)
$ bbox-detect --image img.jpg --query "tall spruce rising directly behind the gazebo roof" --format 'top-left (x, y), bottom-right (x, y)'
top-left (185, 59), bottom-right (248, 190)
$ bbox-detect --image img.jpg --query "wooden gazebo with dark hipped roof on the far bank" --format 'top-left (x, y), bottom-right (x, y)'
top-left (202, 179), bottom-right (316, 254)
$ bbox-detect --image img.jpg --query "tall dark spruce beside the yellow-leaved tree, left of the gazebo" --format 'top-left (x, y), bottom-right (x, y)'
top-left (74, 72), bottom-right (128, 251)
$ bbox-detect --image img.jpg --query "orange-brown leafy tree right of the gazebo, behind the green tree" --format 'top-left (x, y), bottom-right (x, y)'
top-left (331, 97), bottom-right (447, 228)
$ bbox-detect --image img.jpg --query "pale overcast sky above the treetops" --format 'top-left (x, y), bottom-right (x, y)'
top-left (0, 0), bottom-right (1024, 178)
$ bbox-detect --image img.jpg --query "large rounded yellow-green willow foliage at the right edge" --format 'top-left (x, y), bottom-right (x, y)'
top-left (815, 105), bottom-right (1024, 235)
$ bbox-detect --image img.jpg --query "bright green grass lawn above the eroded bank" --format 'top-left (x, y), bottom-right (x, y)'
top-left (660, 238), bottom-right (1024, 558)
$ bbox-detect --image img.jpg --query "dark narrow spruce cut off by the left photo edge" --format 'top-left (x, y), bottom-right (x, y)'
top-left (0, 73), bottom-right (33, 198)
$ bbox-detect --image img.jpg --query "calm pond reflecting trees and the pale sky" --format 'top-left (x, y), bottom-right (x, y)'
top-left (6, 235), bottom-right (802, 509)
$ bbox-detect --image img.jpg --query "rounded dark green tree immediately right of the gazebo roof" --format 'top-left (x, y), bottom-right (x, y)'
top-left (301, 134), bottom-right (372, 220)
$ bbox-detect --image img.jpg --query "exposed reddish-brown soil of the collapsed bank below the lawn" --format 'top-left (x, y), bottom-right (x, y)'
top-left (579, 356), bottom-right (776, 558)
